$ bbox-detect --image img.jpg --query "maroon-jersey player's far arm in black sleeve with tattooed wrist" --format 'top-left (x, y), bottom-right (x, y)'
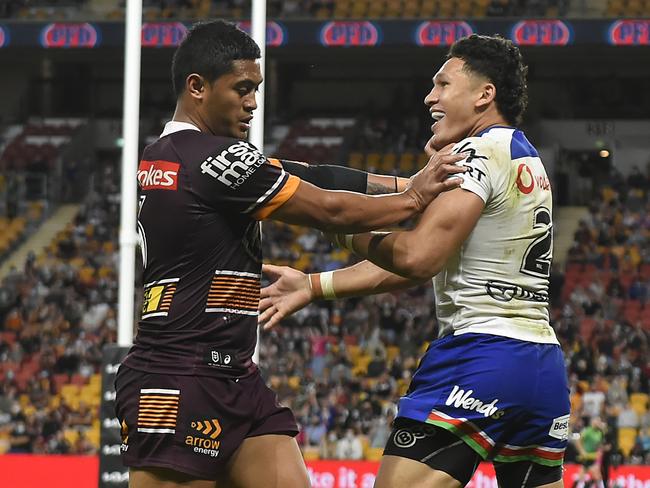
top-left (279, 159), bottom-right (409, 195)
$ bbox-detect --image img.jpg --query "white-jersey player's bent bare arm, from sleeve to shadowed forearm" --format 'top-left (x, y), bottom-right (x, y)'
top-left (336, 189), bottom-right (485, 280)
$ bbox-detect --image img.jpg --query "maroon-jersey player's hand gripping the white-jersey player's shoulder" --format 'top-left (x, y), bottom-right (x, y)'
top-left (406, 144), bottom-right (467, 211)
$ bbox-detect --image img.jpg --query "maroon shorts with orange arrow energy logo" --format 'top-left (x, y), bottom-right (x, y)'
top-left (115, 365), bottom-right (298, 480)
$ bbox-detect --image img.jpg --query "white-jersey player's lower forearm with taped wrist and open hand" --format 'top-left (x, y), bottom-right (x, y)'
top-left (259, 261), bottom-right (422, 330)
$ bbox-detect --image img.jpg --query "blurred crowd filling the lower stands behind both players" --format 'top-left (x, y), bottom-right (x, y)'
top-left (0, 145), bottom-right (650, 472)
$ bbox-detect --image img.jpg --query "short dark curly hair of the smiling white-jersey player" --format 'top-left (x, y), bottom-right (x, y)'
top-left (447, 34), bottom-right (528, 125)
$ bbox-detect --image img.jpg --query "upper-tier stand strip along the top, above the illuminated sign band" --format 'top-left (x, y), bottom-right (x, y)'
top-left (10, 0), bottom-right (636, 21)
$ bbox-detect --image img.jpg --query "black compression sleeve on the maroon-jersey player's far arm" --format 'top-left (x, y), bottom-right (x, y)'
top-left (280, 159), bottom-right (368, 193)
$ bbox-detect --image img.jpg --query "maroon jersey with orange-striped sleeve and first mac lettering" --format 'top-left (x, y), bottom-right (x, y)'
top-left (124, 124), bottom-right (300, 377)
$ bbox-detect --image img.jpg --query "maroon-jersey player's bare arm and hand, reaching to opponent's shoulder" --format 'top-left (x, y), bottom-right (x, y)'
top-left (270, 145), bottom-right (466, 232)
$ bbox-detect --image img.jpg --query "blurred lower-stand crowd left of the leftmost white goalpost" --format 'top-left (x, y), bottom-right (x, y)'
top-left (0, 167), bottom-right (119, 454)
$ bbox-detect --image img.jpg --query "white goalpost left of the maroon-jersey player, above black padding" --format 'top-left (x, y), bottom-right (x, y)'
top-left (117, 0), bottom-right (142, 346)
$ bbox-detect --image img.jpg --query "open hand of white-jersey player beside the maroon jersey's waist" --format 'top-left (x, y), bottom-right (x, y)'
top-left (258, 264), bottom-right (312, 330)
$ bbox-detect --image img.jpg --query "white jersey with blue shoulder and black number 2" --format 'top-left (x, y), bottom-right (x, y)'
top-left (433, 126), bottom-right (558, 344)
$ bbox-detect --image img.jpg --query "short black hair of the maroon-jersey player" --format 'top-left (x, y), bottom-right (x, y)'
top-left (172, 20), bottom-right (261, 98)
